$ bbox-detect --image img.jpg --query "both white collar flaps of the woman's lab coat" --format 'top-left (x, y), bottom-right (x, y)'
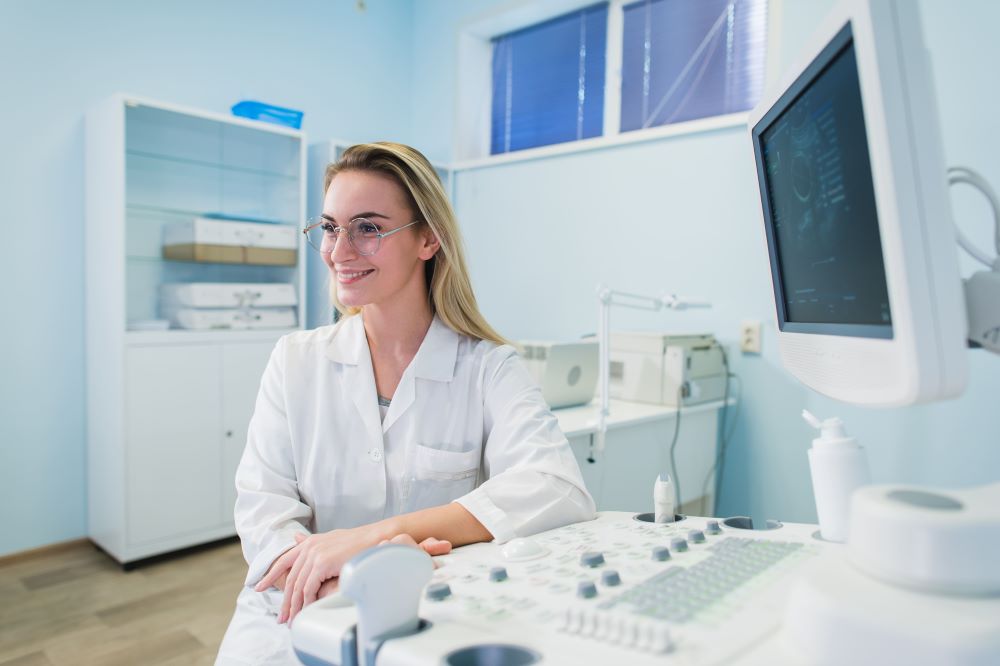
top-left (326, 314), bottom-right (461, 382)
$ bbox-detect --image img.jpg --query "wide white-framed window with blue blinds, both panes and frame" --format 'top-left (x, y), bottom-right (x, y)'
top-left (472, 0), bottom-right (768, 160)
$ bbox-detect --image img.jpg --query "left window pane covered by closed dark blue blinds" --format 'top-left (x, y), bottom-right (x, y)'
top-left (490, 4), bottom-right (608, 154)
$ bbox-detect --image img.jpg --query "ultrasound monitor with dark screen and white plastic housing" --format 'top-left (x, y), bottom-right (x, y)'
top-left (750, 0), bottom-right (966, 406)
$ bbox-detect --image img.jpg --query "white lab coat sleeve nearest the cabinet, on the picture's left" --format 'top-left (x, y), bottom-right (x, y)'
top-left (235, 338), bottom-right (312, 585)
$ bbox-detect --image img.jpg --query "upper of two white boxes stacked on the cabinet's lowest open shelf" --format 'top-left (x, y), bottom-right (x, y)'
top-left (160, 282), bottom-right (299, 308)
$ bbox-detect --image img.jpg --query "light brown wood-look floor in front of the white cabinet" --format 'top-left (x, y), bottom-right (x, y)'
top-left (0, 542), bottom-right (247, 666)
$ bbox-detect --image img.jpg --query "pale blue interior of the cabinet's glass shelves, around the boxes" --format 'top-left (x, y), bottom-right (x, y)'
top-left (122, 100), bottom-right (305, 326)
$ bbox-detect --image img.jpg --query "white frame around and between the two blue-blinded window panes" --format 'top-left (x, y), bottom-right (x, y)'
top-left (452, 0), bottom-right (784, 171)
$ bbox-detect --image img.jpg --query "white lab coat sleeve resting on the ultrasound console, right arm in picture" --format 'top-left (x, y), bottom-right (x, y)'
top-left (456, 345), bottom-right (595, 543)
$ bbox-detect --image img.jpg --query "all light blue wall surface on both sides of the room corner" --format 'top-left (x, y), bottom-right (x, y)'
top-left (0, 0), bottom-right (1000, 555)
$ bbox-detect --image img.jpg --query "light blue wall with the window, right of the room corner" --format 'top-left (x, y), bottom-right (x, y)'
top-left (413, 0), bottom-right (1000, 521)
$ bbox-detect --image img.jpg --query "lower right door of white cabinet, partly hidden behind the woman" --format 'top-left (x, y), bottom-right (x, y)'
top-left (220, 342), bottom-right (274, 525)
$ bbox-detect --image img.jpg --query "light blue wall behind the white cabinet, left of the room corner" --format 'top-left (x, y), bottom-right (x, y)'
top-left (0, 0), bottom-right (412, 555)
